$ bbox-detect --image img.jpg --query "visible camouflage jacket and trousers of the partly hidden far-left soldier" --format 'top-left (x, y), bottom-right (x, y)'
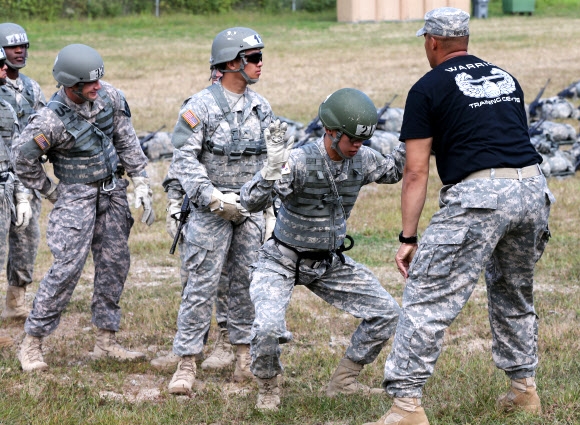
top-left (0, 73), bottom-right (46, 287)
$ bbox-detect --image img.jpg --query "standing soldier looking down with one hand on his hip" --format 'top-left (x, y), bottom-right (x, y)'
top-left (13, 44), bottom-right (155, 371)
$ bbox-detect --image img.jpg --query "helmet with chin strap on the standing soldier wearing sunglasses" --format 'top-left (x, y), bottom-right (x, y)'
top-left (209, 27), bottom-right (264, 84)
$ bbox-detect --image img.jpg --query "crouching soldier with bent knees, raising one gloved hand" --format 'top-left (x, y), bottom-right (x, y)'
top-left (241, 88), bottom-right (405, 410)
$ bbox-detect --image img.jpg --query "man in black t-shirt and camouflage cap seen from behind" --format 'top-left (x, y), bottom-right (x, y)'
top-left (367, 7), bottom-right (554, 425)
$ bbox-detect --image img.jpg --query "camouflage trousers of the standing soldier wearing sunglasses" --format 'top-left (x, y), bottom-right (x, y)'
top-left (173, 211), bottom-right (264, 356)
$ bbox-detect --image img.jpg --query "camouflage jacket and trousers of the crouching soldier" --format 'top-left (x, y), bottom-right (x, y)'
top-left (241, 138), bottom-right (405, 379)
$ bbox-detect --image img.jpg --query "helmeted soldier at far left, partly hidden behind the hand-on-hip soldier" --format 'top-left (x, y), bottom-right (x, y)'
top-left (0, 22), bottom-right (46, 320)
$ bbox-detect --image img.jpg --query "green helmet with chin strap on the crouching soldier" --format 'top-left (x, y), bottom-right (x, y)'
top-left (318, 88), bottom-right (378, 159)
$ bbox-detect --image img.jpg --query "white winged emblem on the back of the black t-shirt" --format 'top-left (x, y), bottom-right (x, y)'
top-left (455, 68), bottom-right (516, 99)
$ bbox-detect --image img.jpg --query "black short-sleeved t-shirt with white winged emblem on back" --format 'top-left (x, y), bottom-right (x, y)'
top-left (400, 55), bottom-right (542, 184)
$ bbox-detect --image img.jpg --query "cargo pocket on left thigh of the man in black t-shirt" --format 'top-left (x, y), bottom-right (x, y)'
top-left (409, 225), bottom-right (469, 277)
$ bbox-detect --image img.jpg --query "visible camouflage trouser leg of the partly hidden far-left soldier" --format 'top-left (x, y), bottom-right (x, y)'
top-left (6, 190), bottom-right (42, 287)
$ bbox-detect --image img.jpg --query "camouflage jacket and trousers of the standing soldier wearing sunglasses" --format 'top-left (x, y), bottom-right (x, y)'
top-left (168, 84), bottom-right (273, 356)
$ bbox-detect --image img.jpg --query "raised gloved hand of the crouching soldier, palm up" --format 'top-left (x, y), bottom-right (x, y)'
top-left (261, 120), bottom-right (294, 180)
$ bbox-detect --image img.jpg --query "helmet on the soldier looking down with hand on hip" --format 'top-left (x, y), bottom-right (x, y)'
top-left (52, 44), bottom-right (105, 87)
